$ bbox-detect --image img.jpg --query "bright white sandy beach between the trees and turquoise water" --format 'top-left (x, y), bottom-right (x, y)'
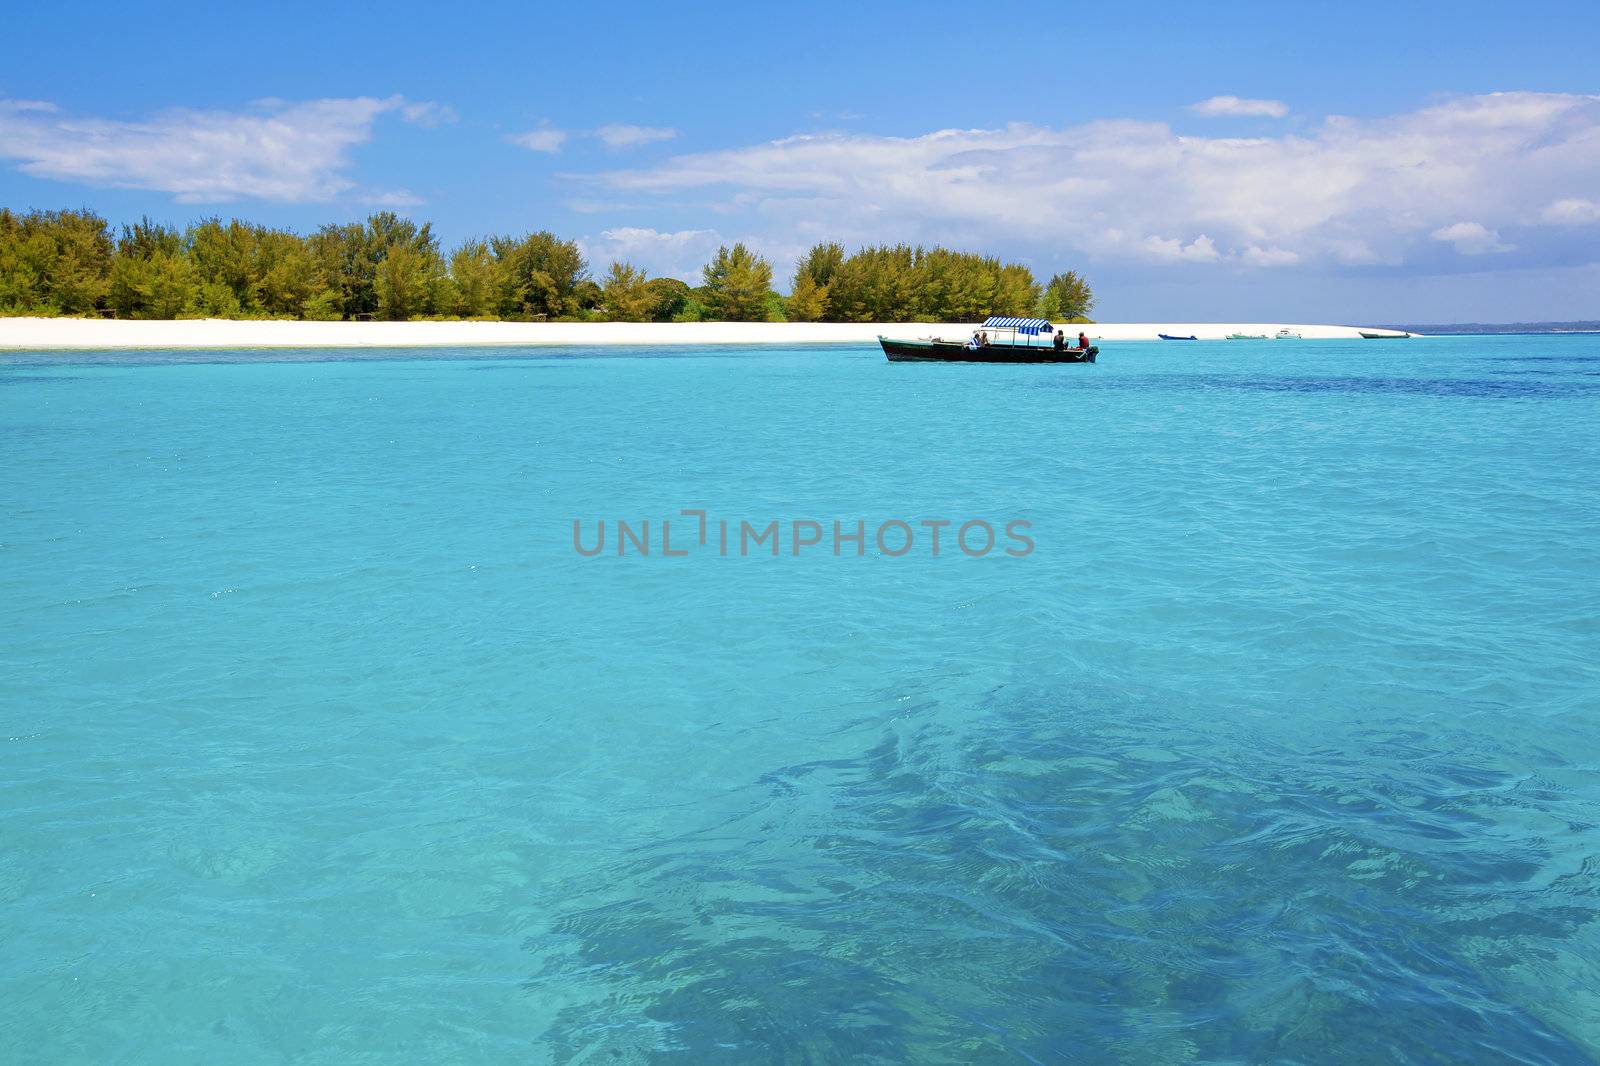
top-left (0, 319), bottom-right (1403, 349)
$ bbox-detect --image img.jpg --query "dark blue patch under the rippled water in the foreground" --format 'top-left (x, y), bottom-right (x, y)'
top-left (525, 683), bottom-right (1600, 1064)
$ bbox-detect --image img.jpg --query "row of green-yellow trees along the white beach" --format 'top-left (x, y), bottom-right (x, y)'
top-left (0, 210), bottom-right (1094, 322)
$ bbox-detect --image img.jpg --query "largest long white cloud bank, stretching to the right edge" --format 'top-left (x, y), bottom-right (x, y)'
top-left (589, 93), bottom-right (1600, 269)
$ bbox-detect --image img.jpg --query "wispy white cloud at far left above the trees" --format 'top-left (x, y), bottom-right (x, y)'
top-left (0, 96), bottom-right (430, 203)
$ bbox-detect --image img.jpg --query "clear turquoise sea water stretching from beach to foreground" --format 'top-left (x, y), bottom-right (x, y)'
top-left (0, 338), bottom-right (1600, 1063)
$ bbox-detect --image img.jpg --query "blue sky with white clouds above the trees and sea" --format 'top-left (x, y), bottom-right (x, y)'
top-left (0, 0), bottom-right (1600, 322)
